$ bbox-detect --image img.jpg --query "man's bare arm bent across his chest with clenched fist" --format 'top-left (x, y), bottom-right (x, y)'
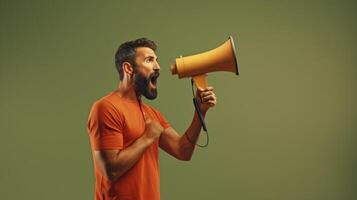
top-left (94, 119), bottom-right (163, 181)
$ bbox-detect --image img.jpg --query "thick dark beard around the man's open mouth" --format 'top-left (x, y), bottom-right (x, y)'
top-left (134, 71), bottom-right (160, 100)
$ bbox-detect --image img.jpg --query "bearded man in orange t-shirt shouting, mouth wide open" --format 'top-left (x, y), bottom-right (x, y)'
top-left (88, 38), bottom-right (216, 200)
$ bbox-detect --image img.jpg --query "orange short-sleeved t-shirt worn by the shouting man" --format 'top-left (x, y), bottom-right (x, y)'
top-left (88, 92), bottom-right (170, 200)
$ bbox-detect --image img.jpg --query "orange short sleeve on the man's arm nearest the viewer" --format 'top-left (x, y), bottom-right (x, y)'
top-left (87, 100), bottom-right (124, 150)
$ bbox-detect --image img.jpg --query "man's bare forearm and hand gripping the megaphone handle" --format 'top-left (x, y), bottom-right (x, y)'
top-left (160, 87), bottom-right (217, 161)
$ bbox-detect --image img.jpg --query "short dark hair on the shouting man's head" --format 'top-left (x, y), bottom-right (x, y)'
top-left (115, 38), bottom-right (156, 80)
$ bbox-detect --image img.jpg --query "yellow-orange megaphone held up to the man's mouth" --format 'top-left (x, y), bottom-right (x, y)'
top-left (170, 36), bottom-right (239, 89)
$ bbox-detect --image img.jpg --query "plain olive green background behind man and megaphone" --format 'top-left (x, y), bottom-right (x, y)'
top-left (0, 0), bottom-right (357, 200)
